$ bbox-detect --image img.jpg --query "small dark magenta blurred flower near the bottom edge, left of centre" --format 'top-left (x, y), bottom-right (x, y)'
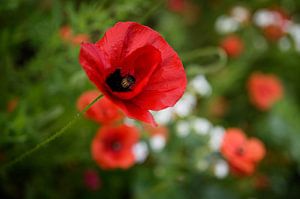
top-left (83, 169), bottom-right (101, 191)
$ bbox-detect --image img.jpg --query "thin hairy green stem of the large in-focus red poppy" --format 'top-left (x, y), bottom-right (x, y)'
top-left (1, 94), bottom-right (103, 172)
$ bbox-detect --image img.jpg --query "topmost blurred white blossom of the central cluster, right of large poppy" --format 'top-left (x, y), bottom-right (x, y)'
top-left (190, 75), bottom-right (212, 96)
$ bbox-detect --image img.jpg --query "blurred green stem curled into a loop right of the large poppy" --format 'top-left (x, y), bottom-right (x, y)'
top-left (180, 47), bottom-right (227, 76)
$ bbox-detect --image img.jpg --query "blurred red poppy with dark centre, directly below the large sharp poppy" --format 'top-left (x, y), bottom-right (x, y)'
top-left (92, 125), bottom-right (139, 169)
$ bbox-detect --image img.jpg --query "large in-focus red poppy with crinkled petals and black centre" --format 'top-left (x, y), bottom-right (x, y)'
top-left (79, 22), bottom-right (187, 125)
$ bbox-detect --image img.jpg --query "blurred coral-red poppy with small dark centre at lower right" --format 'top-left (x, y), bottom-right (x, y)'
top-left (221, 128), bottom-right (266, 175)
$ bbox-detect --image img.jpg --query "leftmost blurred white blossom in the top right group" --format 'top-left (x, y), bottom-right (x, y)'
top-left (215, 15), bottom-right (239, 34)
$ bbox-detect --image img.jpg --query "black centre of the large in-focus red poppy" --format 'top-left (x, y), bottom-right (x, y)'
top-left (105, 69), bottom-right (135, 92)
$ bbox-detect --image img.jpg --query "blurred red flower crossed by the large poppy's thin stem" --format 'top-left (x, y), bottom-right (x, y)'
top-left (77, 90), bottom-right (124, 124)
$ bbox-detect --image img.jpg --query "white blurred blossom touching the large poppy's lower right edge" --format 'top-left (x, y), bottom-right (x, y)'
top-left (174, 93), bottom-right (197, 117)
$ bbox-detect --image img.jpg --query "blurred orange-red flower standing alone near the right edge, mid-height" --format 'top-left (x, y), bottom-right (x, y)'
top-left (248, 72), bottom-right (283, 111)
